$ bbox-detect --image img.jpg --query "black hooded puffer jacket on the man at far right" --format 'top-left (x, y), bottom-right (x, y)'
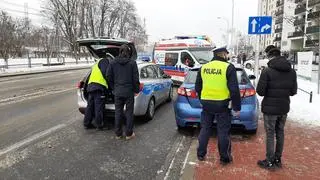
top-left (257, 56), bottom-right (298, 115)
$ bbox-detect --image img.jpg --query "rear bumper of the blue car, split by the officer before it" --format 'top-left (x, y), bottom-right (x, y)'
top-left (174, 103), bottom-right (258, 130)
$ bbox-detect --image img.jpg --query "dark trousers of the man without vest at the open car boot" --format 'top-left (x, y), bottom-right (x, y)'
top-left (115, 96), bottom-right (134, 136)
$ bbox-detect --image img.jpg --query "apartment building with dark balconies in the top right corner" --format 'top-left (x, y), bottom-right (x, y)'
top-left (288, 0), bottom-right (320, 51)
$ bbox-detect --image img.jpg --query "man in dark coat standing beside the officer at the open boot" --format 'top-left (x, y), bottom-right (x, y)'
top-left (107, 45), bottom-right (140, 140)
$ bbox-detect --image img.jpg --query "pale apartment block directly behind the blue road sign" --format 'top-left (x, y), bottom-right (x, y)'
top-left (260, 0), bottom-right (295, 51)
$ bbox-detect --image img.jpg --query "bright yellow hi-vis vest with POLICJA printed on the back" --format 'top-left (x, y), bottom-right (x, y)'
top-left (201, 60), bottom-right (230, 101)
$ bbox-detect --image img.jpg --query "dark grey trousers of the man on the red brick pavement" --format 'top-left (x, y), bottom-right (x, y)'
top-left (263, 114), bottom-right (287, 161)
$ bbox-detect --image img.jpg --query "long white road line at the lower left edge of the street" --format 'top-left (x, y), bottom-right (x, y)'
top-left (0, 124), bottom-right (67, 156)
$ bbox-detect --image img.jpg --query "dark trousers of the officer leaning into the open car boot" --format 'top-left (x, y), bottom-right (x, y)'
top-left (83, 91), bottom-right (106, 127)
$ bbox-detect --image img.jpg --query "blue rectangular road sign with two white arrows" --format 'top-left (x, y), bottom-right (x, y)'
top-left (248, 16), bottom-right (272, 34)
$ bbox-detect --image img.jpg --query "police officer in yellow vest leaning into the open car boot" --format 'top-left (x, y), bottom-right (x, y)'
top-left (83, 58), bottom-right (109, 130)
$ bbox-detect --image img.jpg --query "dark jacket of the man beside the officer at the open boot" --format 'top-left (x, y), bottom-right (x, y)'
top-left (107, 57), bottom-right (140, 97)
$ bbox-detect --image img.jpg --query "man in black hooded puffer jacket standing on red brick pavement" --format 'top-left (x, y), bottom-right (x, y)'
top-left (257, 45), bottom-right (297, 169)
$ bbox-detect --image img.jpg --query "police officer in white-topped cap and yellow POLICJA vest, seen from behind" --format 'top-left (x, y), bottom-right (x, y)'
top-left (195, 48), bottom-right (241, 165)
